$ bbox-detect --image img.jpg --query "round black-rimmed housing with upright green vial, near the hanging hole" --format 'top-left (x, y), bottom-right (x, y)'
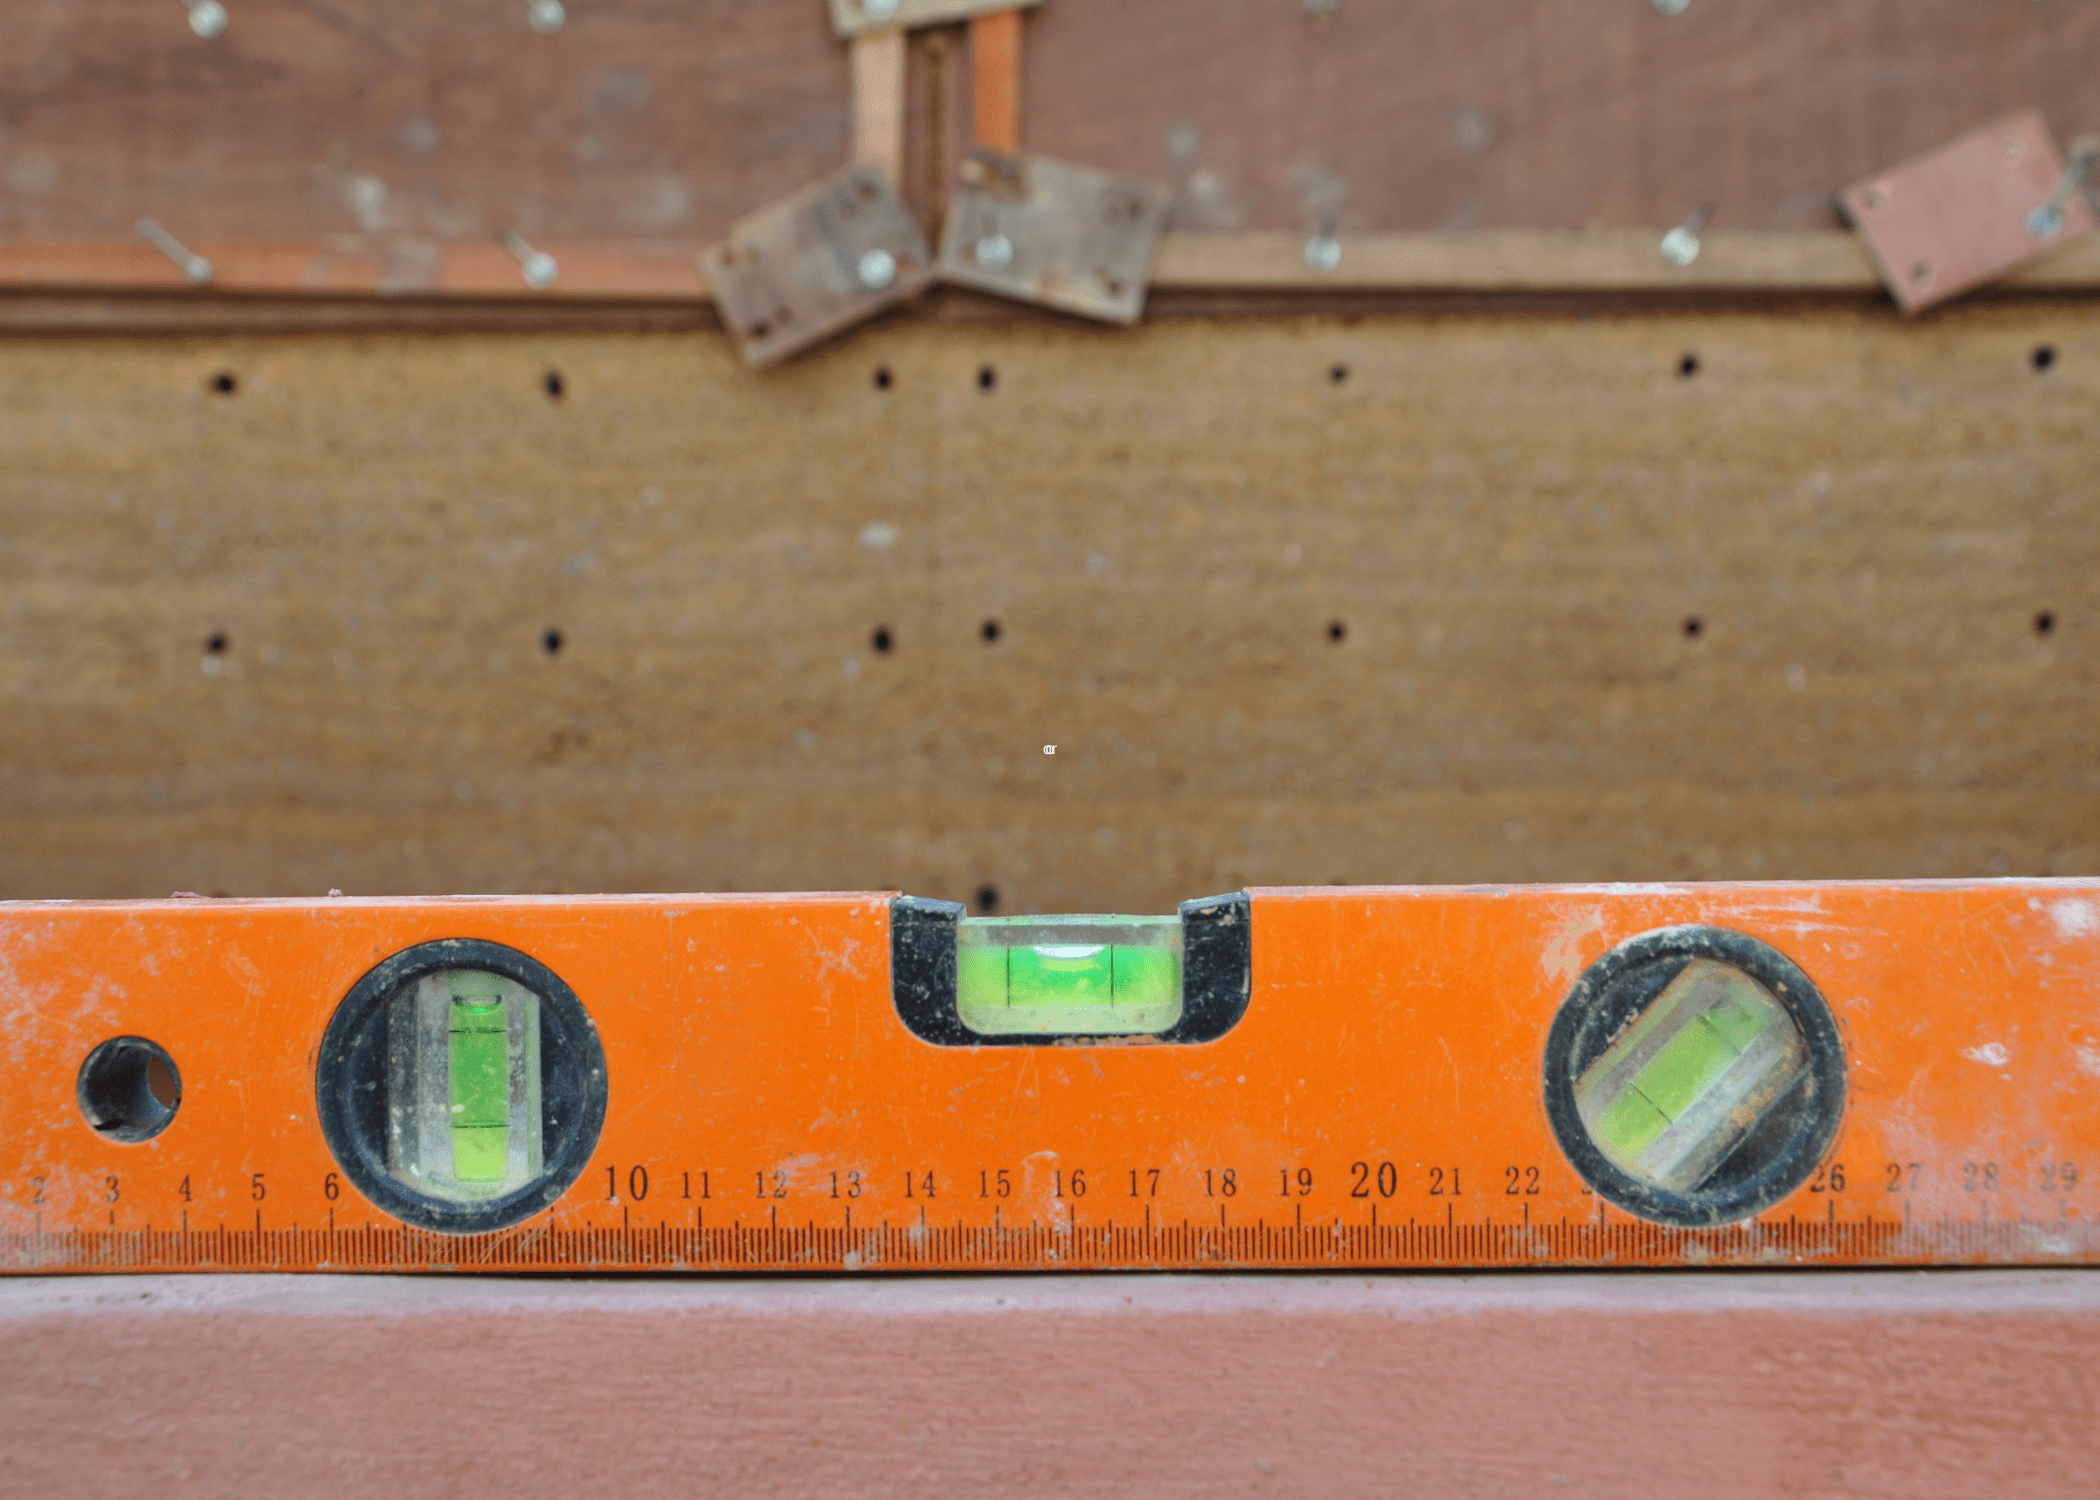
top-left (313, 937), bottom-right (605, 1235)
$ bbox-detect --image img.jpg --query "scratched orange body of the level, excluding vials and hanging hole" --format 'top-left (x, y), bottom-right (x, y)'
top-left (0, 880), bottom-right (2100, 1271)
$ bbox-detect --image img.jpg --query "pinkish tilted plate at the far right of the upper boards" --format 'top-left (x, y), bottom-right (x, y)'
top-left (1838, 109), bottom-right (2094, 313)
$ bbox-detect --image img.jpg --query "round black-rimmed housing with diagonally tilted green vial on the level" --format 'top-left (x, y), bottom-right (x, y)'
top-left (1544, 926), bottom-right (1846, 1229)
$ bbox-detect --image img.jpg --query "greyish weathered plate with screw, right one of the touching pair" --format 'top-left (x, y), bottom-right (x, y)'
top-left (941, 149), bottom-right (1170, 324)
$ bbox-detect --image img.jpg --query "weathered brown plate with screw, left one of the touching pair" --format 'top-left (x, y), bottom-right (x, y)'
top-left (699, 164), bottom-right (932, 366)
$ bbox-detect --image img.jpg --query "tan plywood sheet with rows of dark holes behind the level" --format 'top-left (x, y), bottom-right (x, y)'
top-left (0, 303), bottom-right (2100, 910)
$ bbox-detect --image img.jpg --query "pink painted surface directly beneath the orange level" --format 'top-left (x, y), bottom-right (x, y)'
top-left (0, 1271), bottom-right (2100, 1500)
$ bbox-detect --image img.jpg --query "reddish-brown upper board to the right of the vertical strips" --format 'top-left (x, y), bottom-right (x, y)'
top-left (1023, 0), bottom-right (2100, 233)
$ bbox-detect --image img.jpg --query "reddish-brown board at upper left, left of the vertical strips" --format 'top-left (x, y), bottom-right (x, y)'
top-left (0, 0), bottom-right (853, 244)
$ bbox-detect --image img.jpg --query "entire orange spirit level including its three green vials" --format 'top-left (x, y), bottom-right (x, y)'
top-left (0, 880), bottom-right (2100, 1273)
